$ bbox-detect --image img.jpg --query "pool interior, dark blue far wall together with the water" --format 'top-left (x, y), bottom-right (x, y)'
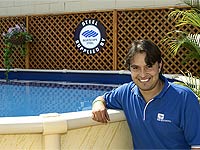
top-left (0, 69), bottom-right (130, 117)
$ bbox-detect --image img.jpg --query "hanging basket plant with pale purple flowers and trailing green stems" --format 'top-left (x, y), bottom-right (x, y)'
top-left (3, 25), bottom-right (32, 79)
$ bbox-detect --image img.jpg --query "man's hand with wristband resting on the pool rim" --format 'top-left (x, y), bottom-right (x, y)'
top-left (92, 97), bottom-right (110, 123)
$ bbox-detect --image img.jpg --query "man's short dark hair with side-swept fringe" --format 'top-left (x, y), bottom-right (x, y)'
top-left (125, 40), bottom-right (162, 69)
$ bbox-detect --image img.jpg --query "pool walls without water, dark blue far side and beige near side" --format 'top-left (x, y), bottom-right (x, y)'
top-left (0, 69), bottom-right (133, 150)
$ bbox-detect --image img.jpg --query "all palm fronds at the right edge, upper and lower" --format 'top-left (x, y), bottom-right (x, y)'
top-left (164, 0), bottom-right (200, 100)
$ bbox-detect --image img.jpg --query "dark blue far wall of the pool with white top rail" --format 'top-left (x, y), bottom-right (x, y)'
top-left (0, 69), bottom-right (131, 84)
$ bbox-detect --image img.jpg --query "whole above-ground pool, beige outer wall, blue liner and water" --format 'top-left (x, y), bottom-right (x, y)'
top-left (0, 69), bottom-right (180, 150)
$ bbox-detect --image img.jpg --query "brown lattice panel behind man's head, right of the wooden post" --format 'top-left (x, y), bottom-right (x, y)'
top-left (117, 9), bottom-right (200, 75)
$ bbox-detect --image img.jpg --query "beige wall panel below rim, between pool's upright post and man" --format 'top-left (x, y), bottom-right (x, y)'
top-left (61, 121), bottom-right (132, 150)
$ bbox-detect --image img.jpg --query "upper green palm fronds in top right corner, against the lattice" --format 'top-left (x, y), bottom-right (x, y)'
top-left (163, 0), bottom-right (200, 61)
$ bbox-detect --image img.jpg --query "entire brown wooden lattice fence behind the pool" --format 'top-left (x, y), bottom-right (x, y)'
top-left (0, 8), bottom-right (200, 75)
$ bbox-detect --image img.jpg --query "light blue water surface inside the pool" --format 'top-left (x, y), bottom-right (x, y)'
top-left (0, 81), bottom-right (117, 117)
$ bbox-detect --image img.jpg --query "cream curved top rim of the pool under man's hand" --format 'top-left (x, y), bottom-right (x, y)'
top-left (0, 109), bottom-right (125, 135)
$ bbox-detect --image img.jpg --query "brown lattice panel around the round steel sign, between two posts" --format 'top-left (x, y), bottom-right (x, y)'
top-left (29, 12), bottom-right (113, 70)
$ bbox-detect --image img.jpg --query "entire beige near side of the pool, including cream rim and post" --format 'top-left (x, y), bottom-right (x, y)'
top-left (0, 110), bottom-right (133, 150)
